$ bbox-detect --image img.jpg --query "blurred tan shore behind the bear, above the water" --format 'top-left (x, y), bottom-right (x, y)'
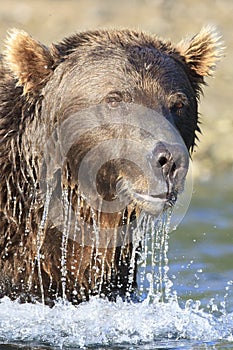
top-left (0, 0), bottom-right (233, 181)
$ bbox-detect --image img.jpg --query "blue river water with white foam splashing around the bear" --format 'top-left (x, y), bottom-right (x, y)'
top-left (0, 176), bottom-right (233, 350)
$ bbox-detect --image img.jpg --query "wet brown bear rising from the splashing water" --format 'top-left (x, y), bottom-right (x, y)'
top-left (0, 27), bottom-right (221, 303)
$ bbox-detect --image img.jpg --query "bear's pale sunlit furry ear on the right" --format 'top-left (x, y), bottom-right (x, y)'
top-left (176, 26), bottom-right (224, 77)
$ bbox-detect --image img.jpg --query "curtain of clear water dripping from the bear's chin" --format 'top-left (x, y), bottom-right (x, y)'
top-left (135, 210), bottom-right (172, 302)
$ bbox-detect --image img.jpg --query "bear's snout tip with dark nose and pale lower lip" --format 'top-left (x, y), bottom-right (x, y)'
top-left (129, 141), bottom-right (189, 215)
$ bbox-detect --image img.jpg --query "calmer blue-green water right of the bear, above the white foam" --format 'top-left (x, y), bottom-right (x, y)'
top-left (169, 175), bottom-right (233, 312)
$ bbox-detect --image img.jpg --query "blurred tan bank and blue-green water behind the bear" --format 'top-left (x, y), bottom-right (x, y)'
top-left (0, 0), bottom-right (233, 326)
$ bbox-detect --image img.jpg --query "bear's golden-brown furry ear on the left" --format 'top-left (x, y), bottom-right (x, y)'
top-left (4, 29), bottom-right (54, 94)
